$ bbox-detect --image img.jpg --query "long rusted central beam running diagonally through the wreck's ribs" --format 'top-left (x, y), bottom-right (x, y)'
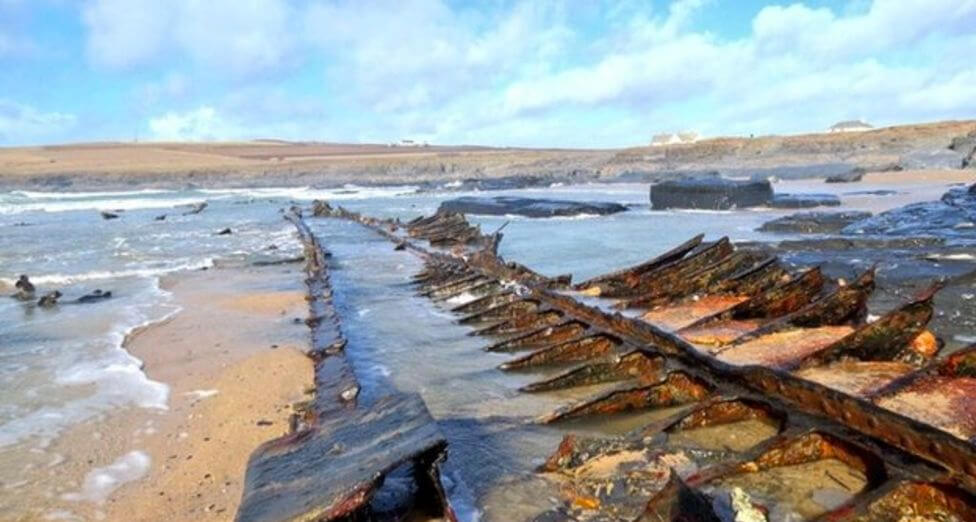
top-left (320, 207), bottom-right (976, 491)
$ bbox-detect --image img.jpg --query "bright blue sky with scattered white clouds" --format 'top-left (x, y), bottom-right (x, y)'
top-left (0, 0), bottom-right (976, 148)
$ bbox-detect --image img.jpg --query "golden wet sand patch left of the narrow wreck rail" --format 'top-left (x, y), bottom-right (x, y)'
top-left (16, 265), bottom-right (313, 521)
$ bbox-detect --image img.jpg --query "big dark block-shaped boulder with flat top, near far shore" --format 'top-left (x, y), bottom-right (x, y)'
top-left (651, 178), bottom-right (773, 210)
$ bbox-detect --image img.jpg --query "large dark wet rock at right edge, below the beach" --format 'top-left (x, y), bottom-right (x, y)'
top-left (842, 185), bottom-right (976, 240)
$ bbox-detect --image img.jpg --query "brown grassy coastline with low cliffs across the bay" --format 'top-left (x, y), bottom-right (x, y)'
top-left (0, 121), bottom-right (976, 190)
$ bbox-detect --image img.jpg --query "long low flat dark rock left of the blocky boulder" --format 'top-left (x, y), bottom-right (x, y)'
top-left (437, 196), bottom-right (627, 217)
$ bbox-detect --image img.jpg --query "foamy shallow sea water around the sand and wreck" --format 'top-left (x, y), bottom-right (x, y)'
top-left (0, 179), bottom-right (924, 519)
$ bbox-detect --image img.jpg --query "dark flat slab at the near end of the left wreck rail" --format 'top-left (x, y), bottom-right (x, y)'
top-left (237, 394), bottom-right (447, 522)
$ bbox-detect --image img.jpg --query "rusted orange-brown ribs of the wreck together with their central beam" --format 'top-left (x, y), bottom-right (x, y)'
top-left (326, 206), bottom-right (976, 520)
